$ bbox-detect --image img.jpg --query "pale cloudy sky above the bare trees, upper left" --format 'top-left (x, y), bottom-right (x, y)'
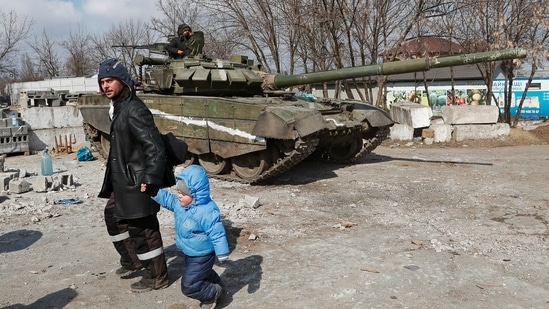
top-left (0, 0), bottom-right (160, 39)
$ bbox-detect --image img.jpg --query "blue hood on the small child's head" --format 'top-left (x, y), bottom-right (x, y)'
top-left (175, 164), bottom-right (211, 204)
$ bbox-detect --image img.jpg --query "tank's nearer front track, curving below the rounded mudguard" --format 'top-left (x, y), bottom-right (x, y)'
top-left (209, 135), bottom-right (319, 185)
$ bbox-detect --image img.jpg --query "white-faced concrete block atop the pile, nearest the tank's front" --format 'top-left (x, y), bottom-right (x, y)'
top-left (391, 102), bottom-right (433, 129)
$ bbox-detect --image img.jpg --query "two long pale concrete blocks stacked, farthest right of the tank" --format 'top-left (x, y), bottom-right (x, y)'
top-left (441, 105), bottom-right (511, 142)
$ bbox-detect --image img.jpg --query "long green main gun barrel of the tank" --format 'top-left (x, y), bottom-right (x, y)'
top-left (263, 48), bottom-right (526, 89)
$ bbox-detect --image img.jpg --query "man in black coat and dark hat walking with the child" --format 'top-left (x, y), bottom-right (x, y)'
top-left (97, 59), bottom-right (169, 292)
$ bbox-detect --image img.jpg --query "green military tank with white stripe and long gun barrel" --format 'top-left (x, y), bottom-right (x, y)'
top-left (78, 44), bottom-right (526, 184)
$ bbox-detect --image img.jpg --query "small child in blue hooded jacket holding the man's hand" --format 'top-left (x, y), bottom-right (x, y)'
top-left (141, 165), bottom-right (229, 308)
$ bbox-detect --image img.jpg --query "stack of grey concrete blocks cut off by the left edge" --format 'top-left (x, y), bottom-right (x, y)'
top-left (0, 109), bottom-right (29, 155)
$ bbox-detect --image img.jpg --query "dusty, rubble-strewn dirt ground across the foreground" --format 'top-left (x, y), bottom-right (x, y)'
top-left (0, 125), bottom-right (549, 309)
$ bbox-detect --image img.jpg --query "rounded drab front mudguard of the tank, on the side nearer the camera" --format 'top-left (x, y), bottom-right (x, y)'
top-left (252, 106), bottom-right (326, 139)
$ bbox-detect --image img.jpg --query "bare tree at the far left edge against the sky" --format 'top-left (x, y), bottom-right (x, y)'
top-left (0, 10), bottom-right (33, 74)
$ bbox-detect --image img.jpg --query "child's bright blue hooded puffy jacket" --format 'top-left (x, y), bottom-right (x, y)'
top-left (153, 165), bottom-right (229, 256)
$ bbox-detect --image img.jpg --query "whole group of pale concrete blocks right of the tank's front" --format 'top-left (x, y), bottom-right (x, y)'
top-left (391, 102), bottom-right (510, 144)
